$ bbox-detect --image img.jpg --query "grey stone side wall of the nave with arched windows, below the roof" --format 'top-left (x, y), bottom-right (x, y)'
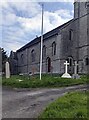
top-left (17, 35), bottom-right (61, 73)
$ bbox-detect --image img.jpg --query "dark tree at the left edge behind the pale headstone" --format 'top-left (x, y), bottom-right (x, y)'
top-left (0, 48), bottom-right (8, 72)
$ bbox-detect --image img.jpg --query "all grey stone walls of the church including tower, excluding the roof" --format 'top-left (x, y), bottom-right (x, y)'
top-left (14, 2), bottom-right (89, 74)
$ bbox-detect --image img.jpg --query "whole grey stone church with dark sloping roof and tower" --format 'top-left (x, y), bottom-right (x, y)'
top-left (10, 1), bottom-right (89, 74)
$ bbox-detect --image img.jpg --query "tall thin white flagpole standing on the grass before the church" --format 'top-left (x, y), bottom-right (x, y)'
top-left (40, 4), bottom-right (43, 80)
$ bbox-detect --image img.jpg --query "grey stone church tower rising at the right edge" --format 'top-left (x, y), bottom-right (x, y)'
top-left (74, 0), bottom-right (89, 73)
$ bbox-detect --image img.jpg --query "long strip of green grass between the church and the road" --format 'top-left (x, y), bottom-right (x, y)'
top-left (0, 74), bottom-right (89, 88)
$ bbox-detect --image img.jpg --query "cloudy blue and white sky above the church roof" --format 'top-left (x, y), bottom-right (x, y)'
top-left (0, 0), bottom-right (74, 55)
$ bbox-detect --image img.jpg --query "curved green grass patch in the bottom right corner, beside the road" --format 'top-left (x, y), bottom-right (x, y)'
top-left (39, 91), bottom-right (89, 120)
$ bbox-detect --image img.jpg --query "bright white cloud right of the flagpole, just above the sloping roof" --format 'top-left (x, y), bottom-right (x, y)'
top-left (44, 9), bottom-right (72, 32)
